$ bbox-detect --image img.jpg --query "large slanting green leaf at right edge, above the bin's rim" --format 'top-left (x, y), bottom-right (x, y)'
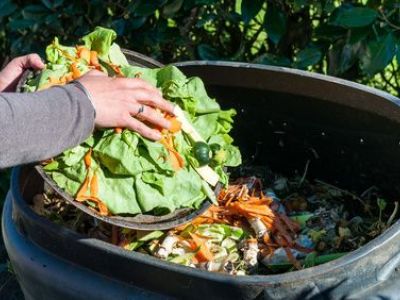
top-left (360, 33), bottom-right (396, 77)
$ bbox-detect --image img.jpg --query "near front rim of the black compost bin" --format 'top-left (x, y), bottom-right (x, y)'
top-left (11, 166), bottom-right (400, 284)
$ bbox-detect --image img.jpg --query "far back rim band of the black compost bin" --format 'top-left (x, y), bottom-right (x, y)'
top-left (174, 61), bottom-right (400, 122)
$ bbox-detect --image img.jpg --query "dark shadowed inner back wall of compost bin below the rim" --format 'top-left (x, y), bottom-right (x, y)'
top-left (207, 85), bottom-right (400, 199)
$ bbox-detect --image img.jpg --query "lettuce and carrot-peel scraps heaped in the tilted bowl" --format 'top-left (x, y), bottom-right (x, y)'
top-left (24, 27), bottom-right (241, 216)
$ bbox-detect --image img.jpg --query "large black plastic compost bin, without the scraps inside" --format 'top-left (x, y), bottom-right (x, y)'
top-left (2, 54), bottom-right (400, 300)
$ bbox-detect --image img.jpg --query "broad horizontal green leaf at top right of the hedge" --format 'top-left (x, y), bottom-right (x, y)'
top-left (329, 7), bottom-right (378, 28)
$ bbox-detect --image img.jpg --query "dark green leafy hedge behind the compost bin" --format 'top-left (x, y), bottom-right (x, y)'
top-left (0, 0), bottom-right (400, 203)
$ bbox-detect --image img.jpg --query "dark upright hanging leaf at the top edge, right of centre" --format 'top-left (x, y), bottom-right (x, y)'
top-left (264, 3), bottom-right (286, 44)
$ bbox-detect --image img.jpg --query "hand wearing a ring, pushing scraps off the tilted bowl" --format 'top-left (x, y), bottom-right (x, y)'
top-left (79, 71), bottom-right (174, 140)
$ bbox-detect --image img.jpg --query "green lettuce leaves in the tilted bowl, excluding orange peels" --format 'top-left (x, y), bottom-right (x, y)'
top-left (28, 27), bottom-right (241, 215)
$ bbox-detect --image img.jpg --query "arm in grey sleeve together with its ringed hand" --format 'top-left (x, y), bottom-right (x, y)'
top-left (0, 56), bottom-right (173, 169)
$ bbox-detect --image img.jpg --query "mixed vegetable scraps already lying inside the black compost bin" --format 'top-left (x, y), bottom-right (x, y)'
top-left (33, 166), bottom-right (398, 275)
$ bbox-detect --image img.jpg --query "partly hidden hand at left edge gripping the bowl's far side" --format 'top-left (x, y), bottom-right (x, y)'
top-left (0, 54), bottom-right (44, 92)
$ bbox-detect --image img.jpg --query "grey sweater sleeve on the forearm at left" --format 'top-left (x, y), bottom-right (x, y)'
top-left (0, 85), bottom-right (95, 169)
